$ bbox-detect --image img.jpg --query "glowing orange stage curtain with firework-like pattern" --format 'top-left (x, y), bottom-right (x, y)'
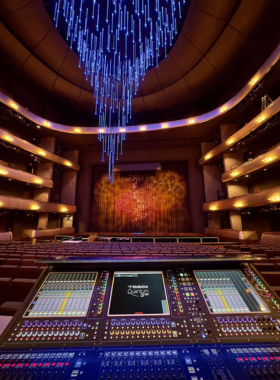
top-left (91, 162), bottom-right (190, 233)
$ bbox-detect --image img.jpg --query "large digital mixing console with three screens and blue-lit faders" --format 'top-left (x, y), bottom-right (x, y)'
top-left (0, 255), bottom-right (280, 380)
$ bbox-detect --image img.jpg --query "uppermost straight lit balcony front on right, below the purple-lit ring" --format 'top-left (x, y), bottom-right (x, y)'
top-left (199, 97), bottom-right (280, 165)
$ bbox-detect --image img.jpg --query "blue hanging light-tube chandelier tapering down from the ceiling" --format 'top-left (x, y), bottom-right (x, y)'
top-left (54, 0), bottom-right (186, 182)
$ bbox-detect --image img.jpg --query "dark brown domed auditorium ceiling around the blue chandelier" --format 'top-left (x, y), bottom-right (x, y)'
top-left (0, 0), bottom-right (280, 129)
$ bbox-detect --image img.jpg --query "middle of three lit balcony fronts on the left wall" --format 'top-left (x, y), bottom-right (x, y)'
top-left (0, 165), bottom-right (53, 188)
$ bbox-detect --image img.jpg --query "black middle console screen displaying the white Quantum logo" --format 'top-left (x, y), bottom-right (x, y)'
top-left (108, 272), bottom-right (169, 316)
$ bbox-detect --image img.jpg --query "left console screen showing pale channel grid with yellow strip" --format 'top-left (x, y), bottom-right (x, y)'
top-left (24, 272), bottom-right (97, 318)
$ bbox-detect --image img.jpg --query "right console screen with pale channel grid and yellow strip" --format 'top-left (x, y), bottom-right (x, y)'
top-left (194, 270), bottom-right (269, 314)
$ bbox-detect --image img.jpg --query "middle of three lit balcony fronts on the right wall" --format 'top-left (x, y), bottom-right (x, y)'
top-left (222, 145), bottom-right (280, 182)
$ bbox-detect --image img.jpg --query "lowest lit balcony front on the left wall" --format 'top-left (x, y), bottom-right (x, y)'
top-left (0, 195), bottom-right (76, 213)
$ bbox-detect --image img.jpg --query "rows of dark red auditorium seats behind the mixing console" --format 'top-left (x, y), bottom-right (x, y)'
top-left (0, 241), bottom-right (280, 315)
